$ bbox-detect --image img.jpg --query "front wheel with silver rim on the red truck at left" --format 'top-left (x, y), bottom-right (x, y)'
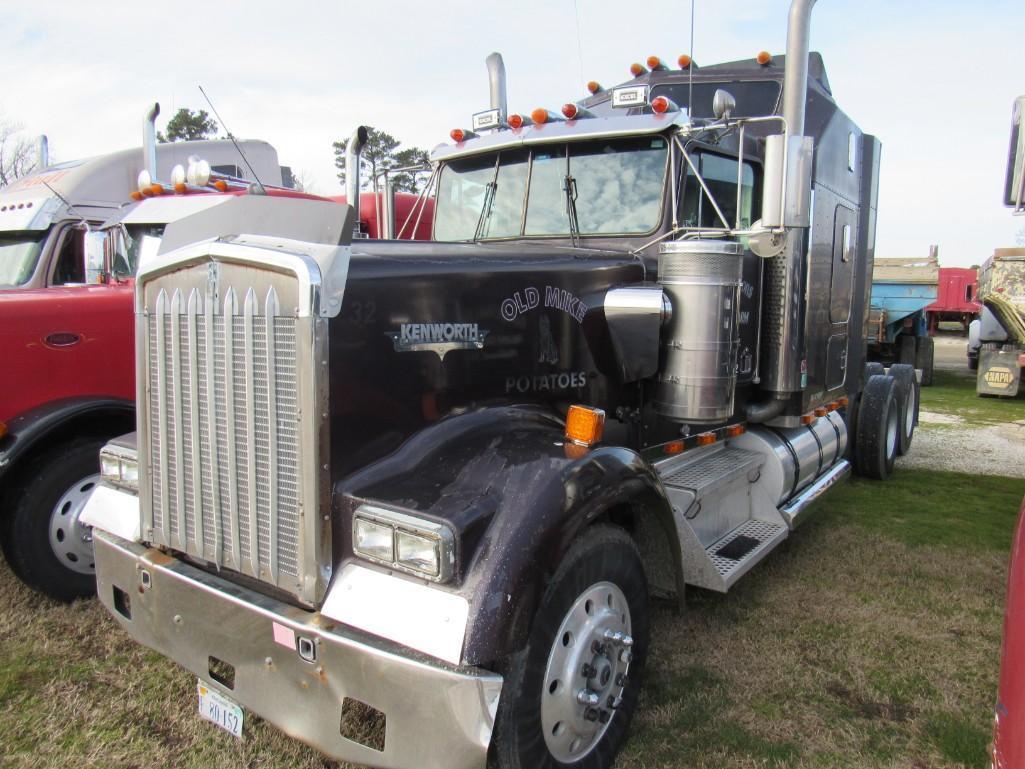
top-left (4, 440), bottom-right (103, 602)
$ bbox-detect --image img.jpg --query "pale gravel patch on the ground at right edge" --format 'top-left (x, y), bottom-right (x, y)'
top-left (897, 418), bottom-right (1025, 478)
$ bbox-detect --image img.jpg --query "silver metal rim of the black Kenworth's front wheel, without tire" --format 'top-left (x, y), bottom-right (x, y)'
top-left (541, 582), bottom-right (633, 764)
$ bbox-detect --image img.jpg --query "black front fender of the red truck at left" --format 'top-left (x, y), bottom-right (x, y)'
top-left (0, 397), bottom-right (135, 484)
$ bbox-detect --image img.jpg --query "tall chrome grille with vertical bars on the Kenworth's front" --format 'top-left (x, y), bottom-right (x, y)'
top-left (144, 276), bottom-right (303, 591)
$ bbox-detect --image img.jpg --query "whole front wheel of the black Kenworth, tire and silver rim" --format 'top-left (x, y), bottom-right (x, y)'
top-left (489, 526), bottom-right (648, 769)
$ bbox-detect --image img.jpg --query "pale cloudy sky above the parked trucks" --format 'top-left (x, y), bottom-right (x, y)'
top-left (0, 0), bottom-right (1025, 266)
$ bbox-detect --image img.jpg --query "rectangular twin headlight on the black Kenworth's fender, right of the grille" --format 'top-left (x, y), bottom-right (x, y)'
top-left (353, 504), bottom-right (455, 582)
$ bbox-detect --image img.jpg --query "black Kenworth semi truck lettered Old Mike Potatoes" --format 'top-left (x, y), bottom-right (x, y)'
top-left (85, 0), bottom-right (916, 769)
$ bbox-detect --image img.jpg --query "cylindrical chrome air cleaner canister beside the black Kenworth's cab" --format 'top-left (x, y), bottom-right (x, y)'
top-left (654, 240), bottom-right (743, 422)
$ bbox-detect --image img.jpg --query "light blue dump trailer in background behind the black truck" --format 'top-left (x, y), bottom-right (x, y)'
top-left (868, 253), bottom-right (940, 386)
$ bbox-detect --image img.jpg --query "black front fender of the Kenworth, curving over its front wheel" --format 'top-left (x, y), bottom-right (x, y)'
top-left (334, 406), bottom-right (679, 664)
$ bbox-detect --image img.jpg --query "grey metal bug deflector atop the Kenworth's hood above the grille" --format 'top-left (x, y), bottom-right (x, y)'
top-left (157, 195), bottom-right (355, 254)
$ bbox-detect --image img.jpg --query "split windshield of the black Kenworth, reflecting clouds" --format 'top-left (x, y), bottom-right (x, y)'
top-left (435, 136), bottom-right (667, 241)
